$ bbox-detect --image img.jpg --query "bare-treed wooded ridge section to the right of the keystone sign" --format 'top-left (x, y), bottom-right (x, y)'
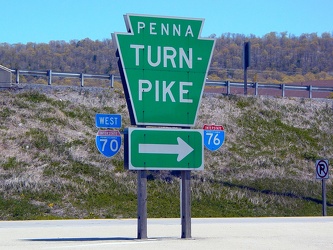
top-left (211, 32), bottom-right (333, 82)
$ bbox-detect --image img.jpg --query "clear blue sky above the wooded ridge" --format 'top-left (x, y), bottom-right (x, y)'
top-left (0, 0), bottom-right (333, 44)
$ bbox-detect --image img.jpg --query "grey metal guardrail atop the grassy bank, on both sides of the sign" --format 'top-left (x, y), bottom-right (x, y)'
top-left (7, 70), bottom-right (333, 98)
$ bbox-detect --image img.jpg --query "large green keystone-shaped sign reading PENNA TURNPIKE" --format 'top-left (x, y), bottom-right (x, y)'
top-left (113, 14), bottom-right (215, 127)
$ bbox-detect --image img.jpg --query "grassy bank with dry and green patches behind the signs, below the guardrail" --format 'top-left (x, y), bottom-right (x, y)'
top-left (0, 85), bottom-right (333, 220)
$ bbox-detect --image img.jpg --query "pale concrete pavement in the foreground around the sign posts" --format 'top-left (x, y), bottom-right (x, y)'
top-left (0, 217), bottom-right (333, 250)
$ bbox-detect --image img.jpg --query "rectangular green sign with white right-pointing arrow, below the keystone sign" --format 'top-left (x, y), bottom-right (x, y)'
top-left (125, 128), bottom-right (204, 170)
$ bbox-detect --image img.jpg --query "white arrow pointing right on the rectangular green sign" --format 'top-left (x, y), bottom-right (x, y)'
top-left (139, 137), bottom-right (194, 162)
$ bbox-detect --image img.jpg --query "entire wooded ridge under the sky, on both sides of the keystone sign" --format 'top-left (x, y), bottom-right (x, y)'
top-left (0, 32), bottom-right (333, 83)
